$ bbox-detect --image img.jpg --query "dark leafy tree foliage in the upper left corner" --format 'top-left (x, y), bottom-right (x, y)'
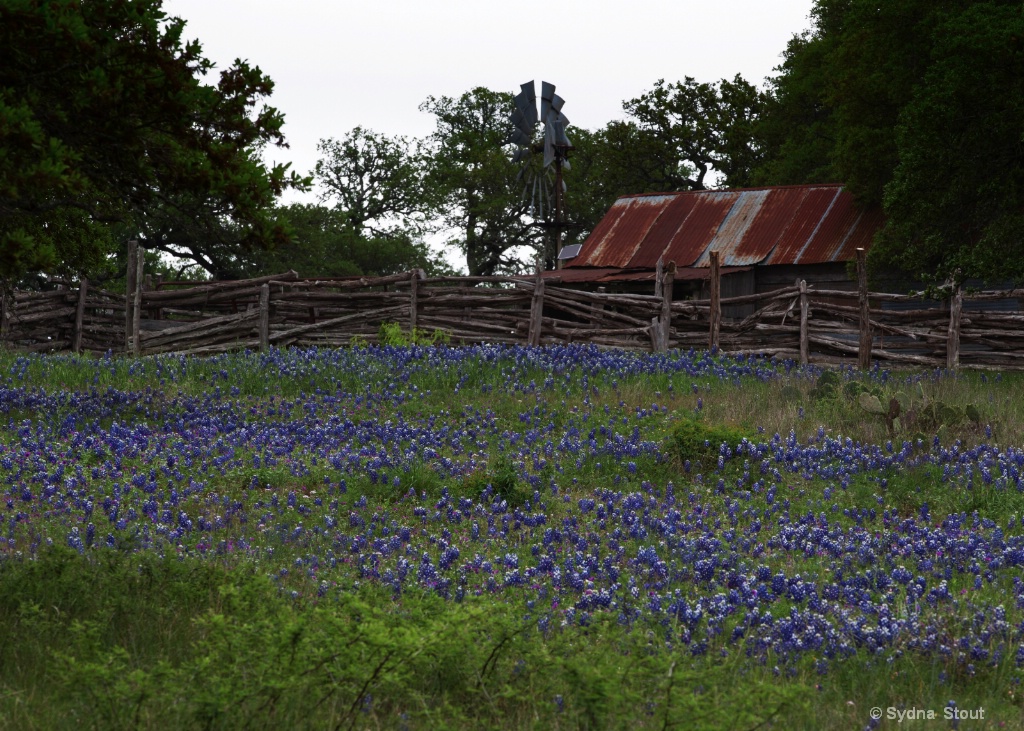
top-left (0, 0), bottom-right (303, 276)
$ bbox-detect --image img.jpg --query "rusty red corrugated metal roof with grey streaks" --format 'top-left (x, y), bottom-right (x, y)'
top-left (565, 184), bottom-right (882, 269)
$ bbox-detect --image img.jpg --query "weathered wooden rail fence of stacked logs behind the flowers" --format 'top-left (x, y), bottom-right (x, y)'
top-left (0, 250), bottom-right (1024, 369)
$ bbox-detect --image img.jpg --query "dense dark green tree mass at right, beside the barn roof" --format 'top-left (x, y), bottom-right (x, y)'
top-left (754, 0), bottom-right (1024, 283)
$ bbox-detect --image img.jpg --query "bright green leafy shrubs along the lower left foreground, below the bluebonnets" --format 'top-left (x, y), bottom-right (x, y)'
top-left (0, 549), bottom-right (808, 730)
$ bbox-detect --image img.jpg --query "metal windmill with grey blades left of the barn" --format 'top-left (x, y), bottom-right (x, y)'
top-left (509, 81), bottom-right (573, 269)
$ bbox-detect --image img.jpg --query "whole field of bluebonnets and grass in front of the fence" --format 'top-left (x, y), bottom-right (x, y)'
top-left (0, 345), bottom-right (1024, 729)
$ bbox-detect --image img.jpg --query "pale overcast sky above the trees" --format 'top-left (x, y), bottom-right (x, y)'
top-left (164, 0), bottom-right (811, 196)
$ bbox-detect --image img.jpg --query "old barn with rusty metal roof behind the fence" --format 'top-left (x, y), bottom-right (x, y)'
top-left (550, 184), bottom-right (883, 315)
